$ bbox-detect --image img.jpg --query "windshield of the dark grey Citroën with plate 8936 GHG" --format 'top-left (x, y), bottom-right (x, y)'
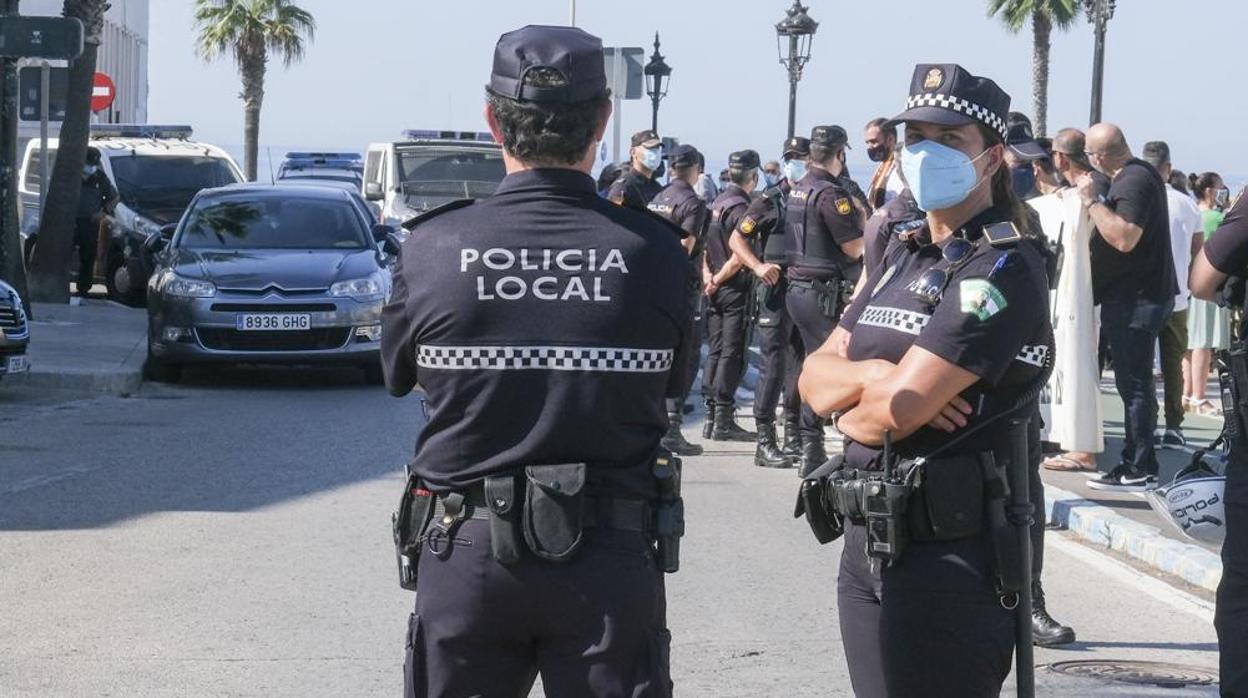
top-left (177, 195), bottom-right (367, 250)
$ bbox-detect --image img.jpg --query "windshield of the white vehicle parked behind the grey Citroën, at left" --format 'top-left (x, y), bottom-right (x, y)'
top-left (109, 155), bottom-right (238, 210)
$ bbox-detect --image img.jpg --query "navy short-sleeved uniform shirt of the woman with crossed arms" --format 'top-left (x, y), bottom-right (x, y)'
top-left (841, 209), bottom-right (1051, 467)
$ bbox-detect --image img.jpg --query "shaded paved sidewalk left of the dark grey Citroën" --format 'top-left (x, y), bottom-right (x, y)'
top-left (0, 298), bottom-right (147, 395)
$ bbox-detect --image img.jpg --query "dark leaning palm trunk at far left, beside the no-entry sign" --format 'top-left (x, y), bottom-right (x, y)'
top-left (29, 0), bottom-right (109, 303)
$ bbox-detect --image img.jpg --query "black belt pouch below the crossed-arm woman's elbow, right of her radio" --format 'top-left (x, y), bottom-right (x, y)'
top-left (899, 456), bottom-right (983, 542)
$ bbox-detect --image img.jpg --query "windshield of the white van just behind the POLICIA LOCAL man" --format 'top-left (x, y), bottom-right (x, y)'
top-left (398, 146), bottom-right (507, 209)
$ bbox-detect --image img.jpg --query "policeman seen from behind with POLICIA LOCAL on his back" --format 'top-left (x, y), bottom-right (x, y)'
top-left (382, 26), bottom-right (691, 697)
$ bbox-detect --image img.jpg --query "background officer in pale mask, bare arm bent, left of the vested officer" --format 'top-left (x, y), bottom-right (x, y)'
top-left (729, 137), bottom-right (810, 468)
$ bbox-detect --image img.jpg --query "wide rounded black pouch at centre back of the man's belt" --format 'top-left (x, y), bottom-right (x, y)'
top-left (522, 463), bottom-right (587, 562)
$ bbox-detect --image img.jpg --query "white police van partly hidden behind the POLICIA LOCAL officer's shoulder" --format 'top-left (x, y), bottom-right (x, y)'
top-left (364, 130), bottom-right (507, 226)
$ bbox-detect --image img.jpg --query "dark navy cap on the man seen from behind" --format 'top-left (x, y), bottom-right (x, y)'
top-left (487, 25), bottom-right (607, 104)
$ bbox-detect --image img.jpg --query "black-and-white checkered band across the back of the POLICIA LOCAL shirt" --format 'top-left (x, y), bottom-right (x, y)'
top-left (416, 345), bottom-right (675, 373)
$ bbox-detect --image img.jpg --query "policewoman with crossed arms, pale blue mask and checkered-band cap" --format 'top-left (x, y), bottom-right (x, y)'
top-left (800, 65), bottom-right (1050, 698)
